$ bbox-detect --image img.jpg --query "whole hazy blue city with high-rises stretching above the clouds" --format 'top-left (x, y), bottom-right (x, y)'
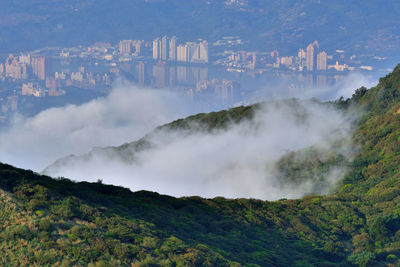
top-left (0, 36), bottom-right (373, 122)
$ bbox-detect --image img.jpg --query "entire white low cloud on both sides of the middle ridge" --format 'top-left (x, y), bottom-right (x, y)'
top-left (0, 74), bottom-right (370, 200)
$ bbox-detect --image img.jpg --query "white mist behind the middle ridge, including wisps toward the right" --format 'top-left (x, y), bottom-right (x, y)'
top-left (0, 73), bottom-right (376, 172)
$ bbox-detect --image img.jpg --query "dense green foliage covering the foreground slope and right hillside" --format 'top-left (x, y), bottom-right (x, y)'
top-left (0, 64), bottom-right (400, 266)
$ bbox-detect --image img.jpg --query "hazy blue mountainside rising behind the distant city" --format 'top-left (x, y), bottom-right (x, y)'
top-left (0, 0), bottom-right (400, 56)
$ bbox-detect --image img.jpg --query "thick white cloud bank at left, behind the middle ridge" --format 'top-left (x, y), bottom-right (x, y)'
top-left (0, 86), bottom-right (190, 171)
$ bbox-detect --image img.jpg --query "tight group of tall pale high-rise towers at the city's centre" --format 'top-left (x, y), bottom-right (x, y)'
top-left (153, 36), bottom-right (209, 64)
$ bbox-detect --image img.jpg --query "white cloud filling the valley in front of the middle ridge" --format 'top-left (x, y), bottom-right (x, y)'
top-left (46, 101), bottom-right (354, 200)
